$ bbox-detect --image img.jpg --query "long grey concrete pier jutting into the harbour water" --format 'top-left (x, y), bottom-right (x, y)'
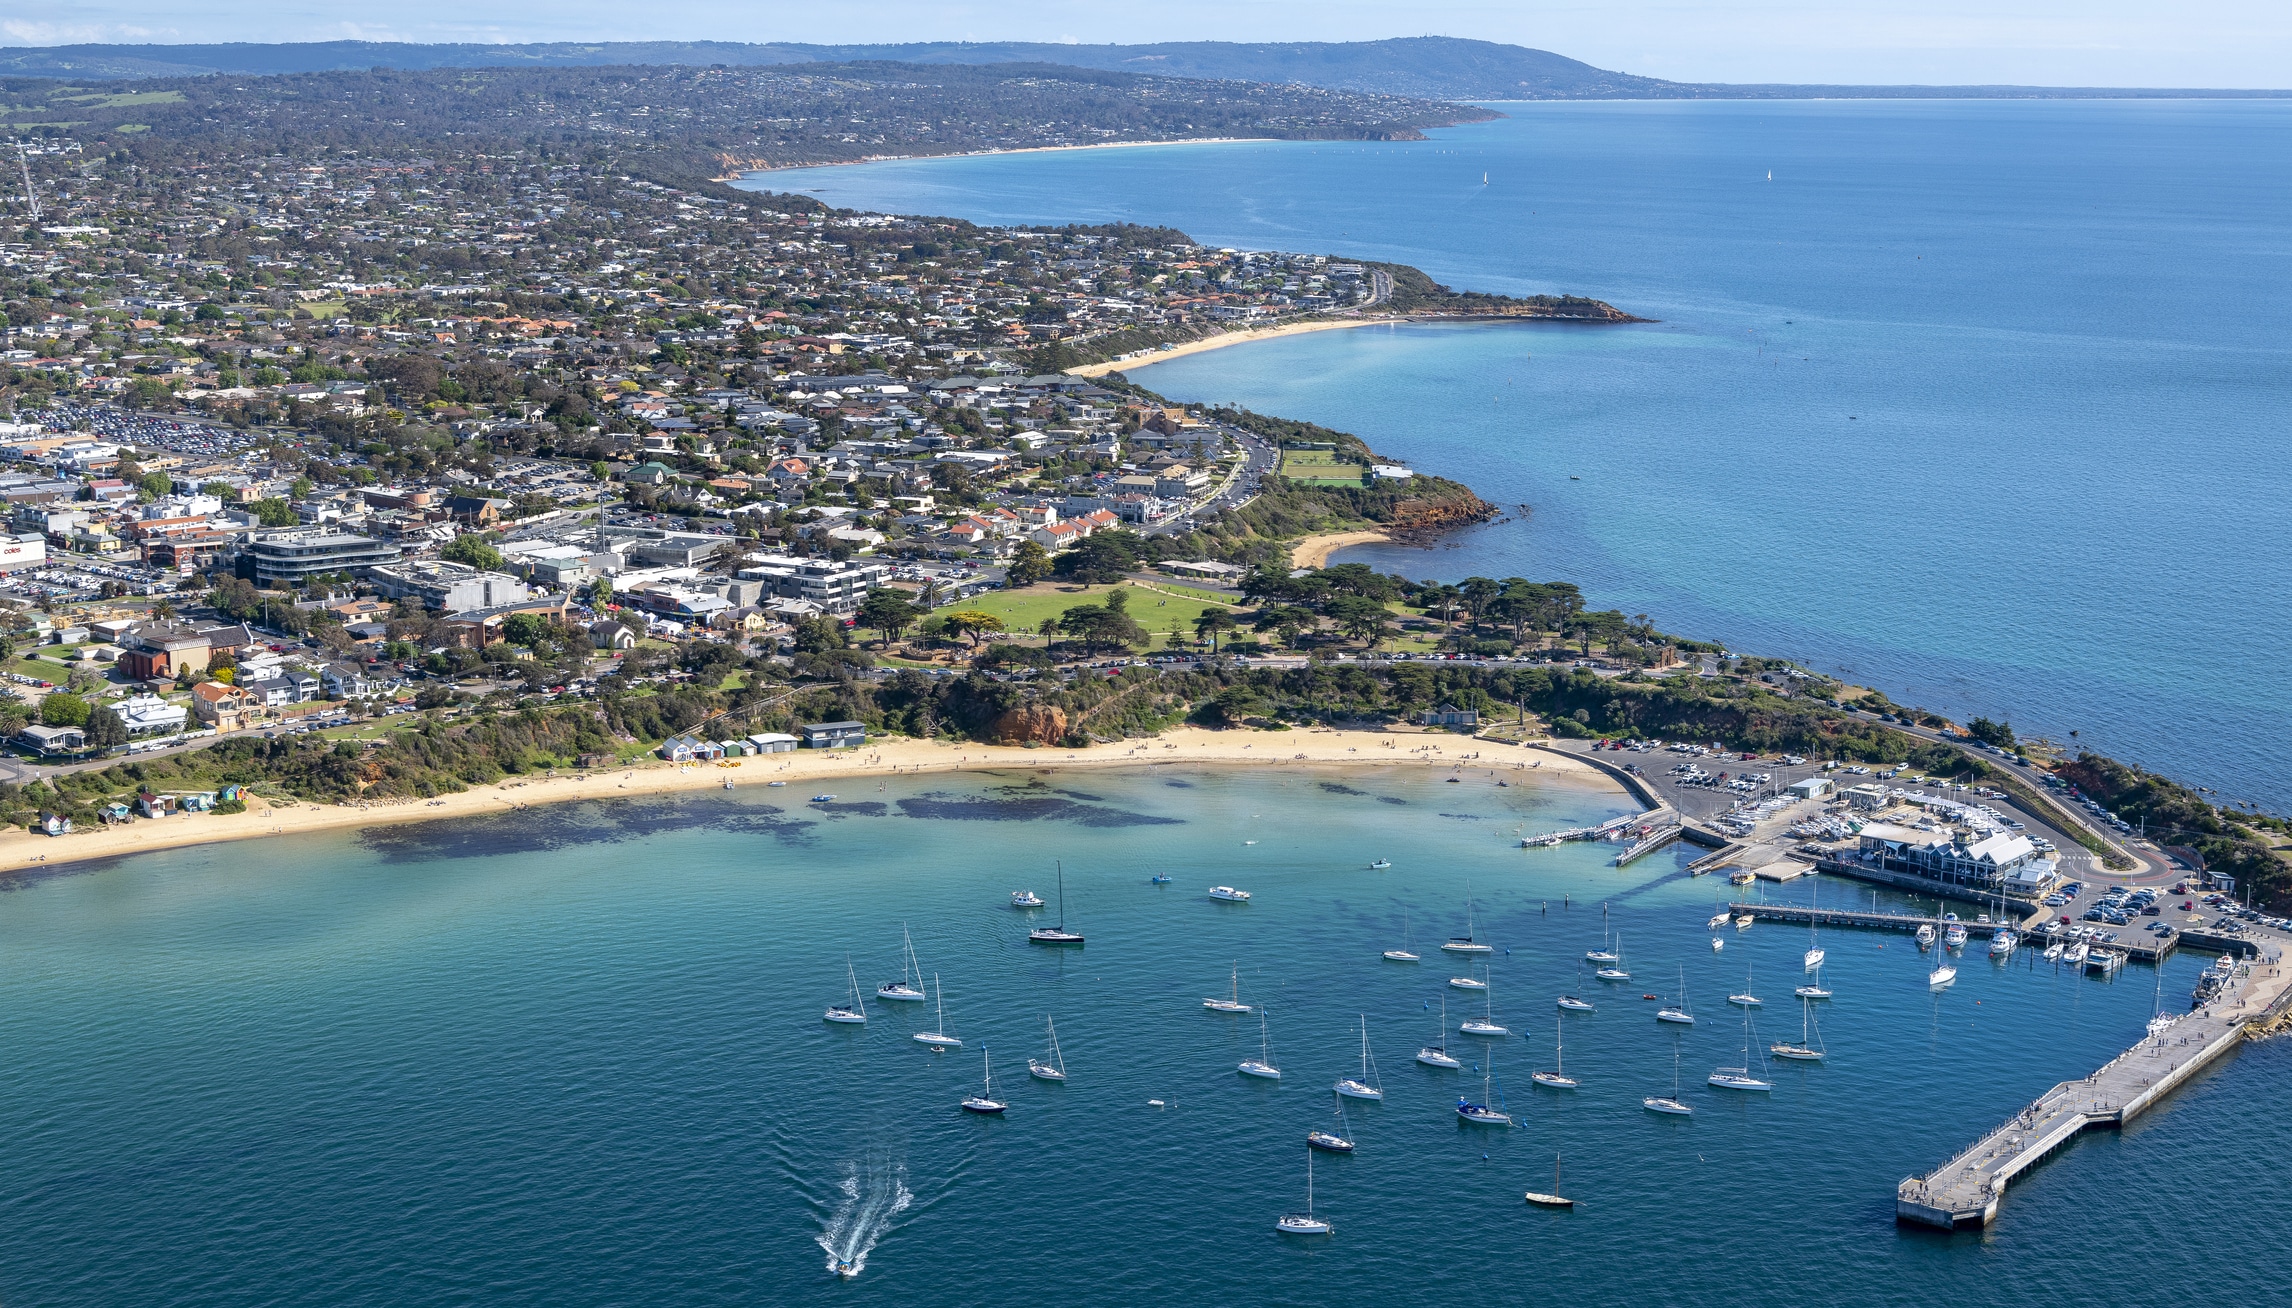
top-left (1893, 944), bottom-right (2292, 1230)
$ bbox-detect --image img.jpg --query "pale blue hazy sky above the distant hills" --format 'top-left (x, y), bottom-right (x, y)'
top-left (0, 0), bottom-right (2292, 87)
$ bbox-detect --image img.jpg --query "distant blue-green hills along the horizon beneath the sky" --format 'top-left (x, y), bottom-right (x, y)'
top-left (0, 37), bottom-right (2292, 101)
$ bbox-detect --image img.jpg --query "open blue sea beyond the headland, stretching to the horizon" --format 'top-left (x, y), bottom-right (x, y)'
top-left (756, 101), bottom-right (2292, 811)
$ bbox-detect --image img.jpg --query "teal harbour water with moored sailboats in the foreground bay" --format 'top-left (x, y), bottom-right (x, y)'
top-left (0, 765), bottom-right (2292, 1306)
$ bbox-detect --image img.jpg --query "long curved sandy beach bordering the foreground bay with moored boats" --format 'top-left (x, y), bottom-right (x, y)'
top-left (0, 728), bottom-right (1609, 870)
